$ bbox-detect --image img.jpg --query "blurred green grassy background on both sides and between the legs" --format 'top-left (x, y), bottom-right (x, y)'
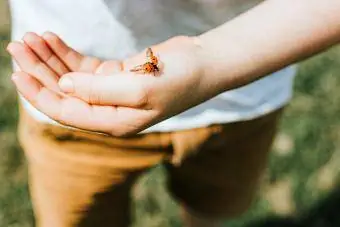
top-left (0, 0), bottom-right (340, 227)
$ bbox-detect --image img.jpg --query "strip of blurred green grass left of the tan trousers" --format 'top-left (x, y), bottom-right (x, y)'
top-left (0, 31), bottom-right (33, 227)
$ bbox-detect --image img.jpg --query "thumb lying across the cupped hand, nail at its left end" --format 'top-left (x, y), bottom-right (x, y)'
top-left (58, 72), bottom-right (147, 107)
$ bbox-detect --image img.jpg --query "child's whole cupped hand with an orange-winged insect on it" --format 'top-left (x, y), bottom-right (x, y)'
top-left (8, 33), bottom-right (219, 136)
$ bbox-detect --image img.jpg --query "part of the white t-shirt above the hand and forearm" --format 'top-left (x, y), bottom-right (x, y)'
top-left (10, 0), bottom-right (263, 58)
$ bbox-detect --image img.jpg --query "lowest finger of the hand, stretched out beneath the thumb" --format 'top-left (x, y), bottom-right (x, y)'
top-left (12, 72), bottom-right (148, 136)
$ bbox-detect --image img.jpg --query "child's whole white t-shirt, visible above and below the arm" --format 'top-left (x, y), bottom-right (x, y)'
top-left (10, 0), bottom-right (296, 132)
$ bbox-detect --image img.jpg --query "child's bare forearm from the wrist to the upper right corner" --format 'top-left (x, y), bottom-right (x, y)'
top-left (198, 0), bottom-right (340, 92)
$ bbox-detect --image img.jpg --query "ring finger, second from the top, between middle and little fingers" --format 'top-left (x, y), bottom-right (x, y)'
top-left (23, 32), bottom-right (69, 76)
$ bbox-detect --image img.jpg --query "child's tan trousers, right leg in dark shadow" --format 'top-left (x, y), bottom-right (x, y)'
top-left (19, 107), bottom-right (282, 227)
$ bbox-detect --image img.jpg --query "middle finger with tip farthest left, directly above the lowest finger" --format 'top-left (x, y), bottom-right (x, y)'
top-left (7, 42), bottom-right (60, 91)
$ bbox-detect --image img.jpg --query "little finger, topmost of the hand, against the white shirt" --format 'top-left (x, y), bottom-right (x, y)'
top-left (42, 32), bottom-right (101, 72)
